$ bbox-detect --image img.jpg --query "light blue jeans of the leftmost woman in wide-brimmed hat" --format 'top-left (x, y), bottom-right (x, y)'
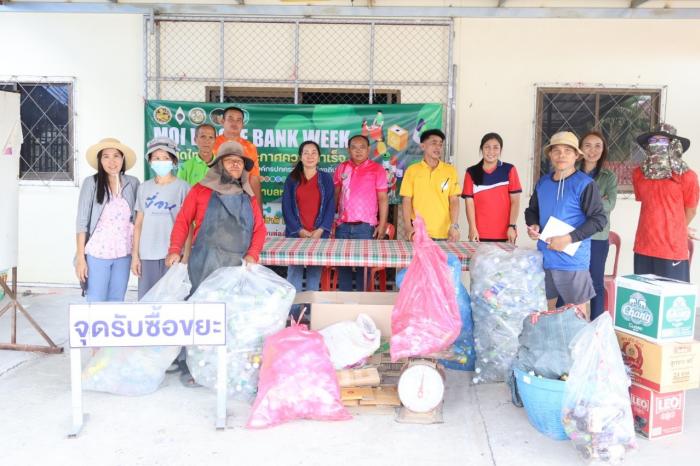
top-left (85, 254), bottom-right (131, 303)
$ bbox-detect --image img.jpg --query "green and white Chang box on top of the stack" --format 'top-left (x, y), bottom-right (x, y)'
top-left (615, 275), bottom-right (697, 341)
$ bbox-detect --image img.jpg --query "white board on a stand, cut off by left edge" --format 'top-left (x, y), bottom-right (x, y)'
top-left (0, 91), bottom-right (22, 272)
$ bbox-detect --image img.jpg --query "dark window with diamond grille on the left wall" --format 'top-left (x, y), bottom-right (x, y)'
top-left (0, 82), bottom-right (75, 182)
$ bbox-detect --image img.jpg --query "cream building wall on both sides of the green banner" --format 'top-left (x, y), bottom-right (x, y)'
top-left (0, 13), bottom-right (700, 292)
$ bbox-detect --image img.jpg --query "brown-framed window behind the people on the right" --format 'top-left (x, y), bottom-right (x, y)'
top-left (534, 87), bottom-right (661, 192)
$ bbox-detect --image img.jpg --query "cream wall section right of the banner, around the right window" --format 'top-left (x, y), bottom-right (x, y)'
top-left (455, 19), bottom-right (700, 283)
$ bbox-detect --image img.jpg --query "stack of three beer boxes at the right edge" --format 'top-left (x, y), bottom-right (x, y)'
top-left (615, 275), bottom-right (700, 439)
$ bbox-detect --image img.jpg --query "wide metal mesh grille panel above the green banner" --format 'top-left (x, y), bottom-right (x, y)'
top-left (144, 15), bottom-right (455, 238)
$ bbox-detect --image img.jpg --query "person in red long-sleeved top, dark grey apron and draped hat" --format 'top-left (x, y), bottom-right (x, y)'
top-left (166, 141), bottom-right (266, 293)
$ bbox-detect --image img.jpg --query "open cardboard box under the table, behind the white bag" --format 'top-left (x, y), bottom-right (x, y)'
top-left (294, 291), bottom-right (399, 338)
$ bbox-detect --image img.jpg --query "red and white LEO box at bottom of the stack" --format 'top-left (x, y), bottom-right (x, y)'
top-left (630, 384), bottom-right (685, 440)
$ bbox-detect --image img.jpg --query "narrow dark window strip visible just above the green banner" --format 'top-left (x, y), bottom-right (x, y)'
top-left (206, 86), bottom-right (401, 105)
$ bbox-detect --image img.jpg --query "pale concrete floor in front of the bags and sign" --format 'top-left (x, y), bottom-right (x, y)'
top-left (0, 288), bottom-right (700, 466)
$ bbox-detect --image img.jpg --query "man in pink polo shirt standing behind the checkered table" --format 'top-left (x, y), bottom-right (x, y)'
top-left (333, 134), bottom-right (389, 291)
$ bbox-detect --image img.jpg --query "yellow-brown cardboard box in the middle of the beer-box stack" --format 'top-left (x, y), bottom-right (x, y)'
top-left (615, 330), bottom-right (700, 393)
